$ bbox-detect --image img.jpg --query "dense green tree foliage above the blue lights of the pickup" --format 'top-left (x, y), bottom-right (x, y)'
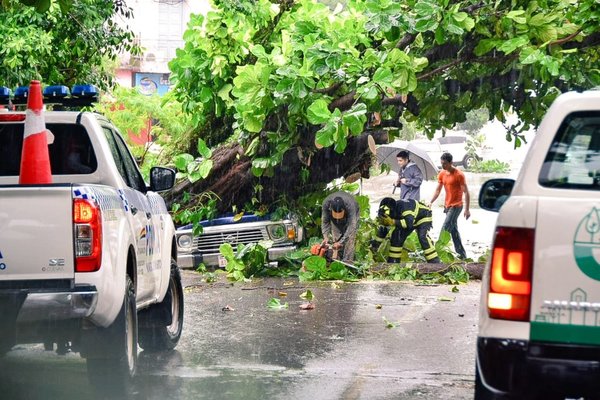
top-left (0, 0), bottom-right (138, 87)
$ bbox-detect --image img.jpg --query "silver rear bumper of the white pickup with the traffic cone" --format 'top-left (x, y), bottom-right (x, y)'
top-left (0, 286), bottom-right (98, 323)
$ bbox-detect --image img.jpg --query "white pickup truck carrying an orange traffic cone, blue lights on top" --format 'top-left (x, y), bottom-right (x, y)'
top-left (0, 104), bottom-right (183, 388)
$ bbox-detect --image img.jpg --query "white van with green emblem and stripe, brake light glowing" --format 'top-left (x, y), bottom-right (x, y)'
top-left (475, 90), bottom-right (600, 400)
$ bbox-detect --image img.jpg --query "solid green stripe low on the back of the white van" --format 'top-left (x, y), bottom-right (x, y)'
top-left (529, 322), bottom-right (600, 345)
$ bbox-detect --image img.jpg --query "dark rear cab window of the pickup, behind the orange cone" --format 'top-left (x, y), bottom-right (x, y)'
top-left (0, 123), bottom-right (98, 176)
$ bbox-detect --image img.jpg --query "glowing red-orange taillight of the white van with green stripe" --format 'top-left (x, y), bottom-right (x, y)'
top-left (487, 227), bottom-right (535, 321)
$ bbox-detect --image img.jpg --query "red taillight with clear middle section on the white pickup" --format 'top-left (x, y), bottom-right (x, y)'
top-left (73, 199), bottom-right (102, 272)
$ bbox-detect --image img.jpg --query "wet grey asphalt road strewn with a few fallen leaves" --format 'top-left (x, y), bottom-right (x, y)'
top-left (0, 271), bottom-right (480, 400)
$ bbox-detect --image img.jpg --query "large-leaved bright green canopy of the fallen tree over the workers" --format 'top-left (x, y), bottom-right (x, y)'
top-left (164, 0), bottom-right (600, 212)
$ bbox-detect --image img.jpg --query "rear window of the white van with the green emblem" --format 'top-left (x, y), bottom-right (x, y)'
top-left (539, 111), bottom-right (600, 190)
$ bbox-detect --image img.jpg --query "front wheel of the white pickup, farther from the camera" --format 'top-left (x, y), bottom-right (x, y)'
top-left (139, 259), bottom-right (183, 351)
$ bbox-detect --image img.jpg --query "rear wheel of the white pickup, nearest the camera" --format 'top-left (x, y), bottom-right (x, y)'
top-left (87, 277), bottom-right (137, 396)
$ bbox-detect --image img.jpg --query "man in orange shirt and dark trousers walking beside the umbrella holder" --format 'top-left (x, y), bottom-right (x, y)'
top-left (430, 153), bottom-right (471, 260)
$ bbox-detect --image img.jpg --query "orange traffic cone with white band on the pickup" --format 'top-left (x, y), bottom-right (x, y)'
top-left (19, 81), bottom-right (52, 184)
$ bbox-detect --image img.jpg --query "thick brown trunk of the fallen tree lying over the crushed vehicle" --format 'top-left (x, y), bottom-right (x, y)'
top-left (165, 130), bottom-right (388, 212)
